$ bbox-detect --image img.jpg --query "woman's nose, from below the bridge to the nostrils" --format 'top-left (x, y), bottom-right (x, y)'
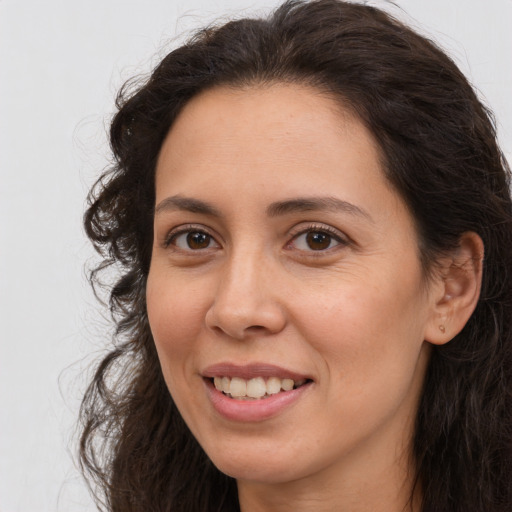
top-left (205, 251), bottom-right (286, 340)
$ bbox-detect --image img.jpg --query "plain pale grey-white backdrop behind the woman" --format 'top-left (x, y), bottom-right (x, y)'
top-left (0, 0), bottom-right (512, 512)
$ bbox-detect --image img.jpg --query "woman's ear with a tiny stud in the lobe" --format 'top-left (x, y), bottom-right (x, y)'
top-left (425, 231), bottom-right (484, 345)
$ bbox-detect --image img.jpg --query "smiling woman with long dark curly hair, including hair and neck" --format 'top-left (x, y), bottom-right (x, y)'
top-left (81, 0), bottom-right (512, 512)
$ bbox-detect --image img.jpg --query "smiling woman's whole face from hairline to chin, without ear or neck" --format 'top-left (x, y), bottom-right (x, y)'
top-left (147, 85), bottom-right (434, 483)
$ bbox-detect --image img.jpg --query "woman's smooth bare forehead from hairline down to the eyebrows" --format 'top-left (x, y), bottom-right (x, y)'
top-left (156, 84), bottom-right (399, 222)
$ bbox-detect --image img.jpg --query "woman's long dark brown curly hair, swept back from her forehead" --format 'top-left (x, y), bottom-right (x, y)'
top-left (80, 0), bottom-right (512, 512)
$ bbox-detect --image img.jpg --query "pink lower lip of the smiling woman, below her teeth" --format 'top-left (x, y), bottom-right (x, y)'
top-left (204, 379), bottom-right (312, 422)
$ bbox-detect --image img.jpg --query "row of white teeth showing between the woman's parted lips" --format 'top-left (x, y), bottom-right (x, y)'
top-left (209, 376), bottom-right (311, 400)
